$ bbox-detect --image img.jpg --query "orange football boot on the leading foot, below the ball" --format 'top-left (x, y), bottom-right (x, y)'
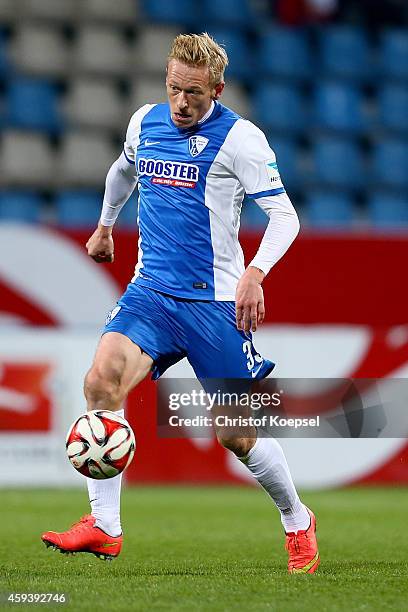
top-left (41, 514), bottom-right (123, 561)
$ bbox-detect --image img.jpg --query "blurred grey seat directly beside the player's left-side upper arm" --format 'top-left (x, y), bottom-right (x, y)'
top-left (56, 131), bottom-right (115, 188)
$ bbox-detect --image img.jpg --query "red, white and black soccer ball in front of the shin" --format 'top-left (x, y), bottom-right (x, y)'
top-left (66, 410), bottom-right (136, 479)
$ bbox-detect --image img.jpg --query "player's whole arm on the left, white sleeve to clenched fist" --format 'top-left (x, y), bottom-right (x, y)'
top-left (86, 104), bottom-right (152, 263)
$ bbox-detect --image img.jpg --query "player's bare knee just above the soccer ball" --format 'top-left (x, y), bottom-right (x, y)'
top-left (84, 367), bottom-right (125, 410)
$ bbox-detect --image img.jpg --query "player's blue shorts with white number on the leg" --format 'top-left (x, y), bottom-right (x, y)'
top-left (103, 283), bottom-right (275, 380)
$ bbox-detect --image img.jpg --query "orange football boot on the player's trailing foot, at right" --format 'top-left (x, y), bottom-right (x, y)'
top-left (285, 508), bottom-right (320, 574)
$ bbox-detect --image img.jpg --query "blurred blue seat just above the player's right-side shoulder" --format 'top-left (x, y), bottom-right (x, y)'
top-left (252, 82), bottom-right (306, 133)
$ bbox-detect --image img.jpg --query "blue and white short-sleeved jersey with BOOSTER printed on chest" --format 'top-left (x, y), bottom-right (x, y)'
top-left (124, 102), bottom-right (284, 301)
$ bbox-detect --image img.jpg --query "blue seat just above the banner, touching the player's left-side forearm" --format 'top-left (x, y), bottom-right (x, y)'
top-left (55, 190), bottom-right (102, 228)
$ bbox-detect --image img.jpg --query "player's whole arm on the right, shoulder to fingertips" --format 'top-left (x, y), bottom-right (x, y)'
top-left (233, 121), bottom-right (299, 332)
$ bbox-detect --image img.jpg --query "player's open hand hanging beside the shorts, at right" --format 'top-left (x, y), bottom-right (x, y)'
top-left (235, 266), bottom-right (265, 332)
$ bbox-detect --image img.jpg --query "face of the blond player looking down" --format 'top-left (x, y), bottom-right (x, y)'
top-left (166, 59), bottom-right (224, 128)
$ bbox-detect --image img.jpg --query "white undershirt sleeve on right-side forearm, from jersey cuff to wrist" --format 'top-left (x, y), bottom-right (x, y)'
top-left (249, 193), bottom-right (300, 274)
